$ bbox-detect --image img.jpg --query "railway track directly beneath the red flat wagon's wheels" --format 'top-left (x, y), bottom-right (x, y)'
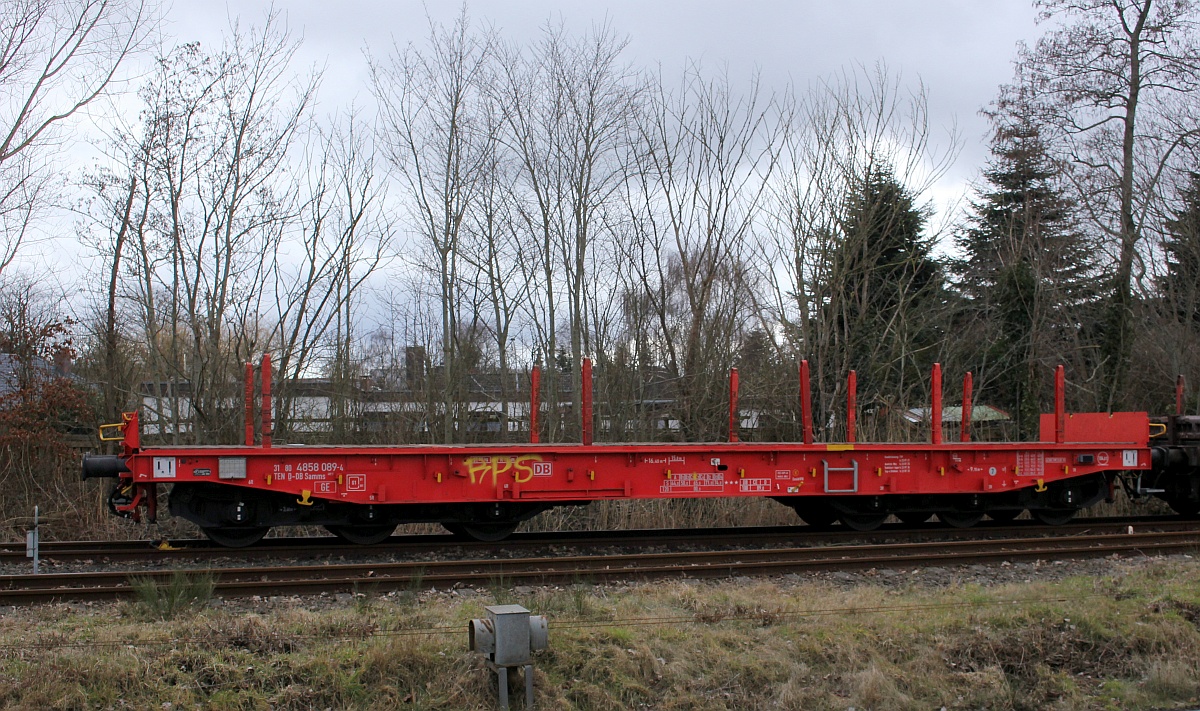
top-left (0, 516), bottom-right (1185, 569)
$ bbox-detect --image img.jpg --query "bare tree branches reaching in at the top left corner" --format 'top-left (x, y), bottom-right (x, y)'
top-left (0, 0), bottom-right (157, 271)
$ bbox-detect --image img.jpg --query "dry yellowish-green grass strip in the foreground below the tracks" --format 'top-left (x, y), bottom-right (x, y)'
top-left (0, 561), bottom-right (1200, 710)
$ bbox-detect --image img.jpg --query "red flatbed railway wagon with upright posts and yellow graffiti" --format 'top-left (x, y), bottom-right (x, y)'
top-left (83, 359), bottom-right (1154, 546)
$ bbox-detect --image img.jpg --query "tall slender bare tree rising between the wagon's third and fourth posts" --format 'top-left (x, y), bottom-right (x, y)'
top-left (496, 19), bottom-right (642, 437)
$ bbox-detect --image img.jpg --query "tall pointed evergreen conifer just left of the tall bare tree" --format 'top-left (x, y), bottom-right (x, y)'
top-left (955, 115), bottom-right (1096, 438)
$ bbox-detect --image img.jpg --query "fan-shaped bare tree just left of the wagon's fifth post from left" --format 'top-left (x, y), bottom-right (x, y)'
top-left (626, 67), bottom-right (779, 438)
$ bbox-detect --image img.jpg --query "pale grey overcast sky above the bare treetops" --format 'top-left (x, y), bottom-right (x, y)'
top-left (166, 0), bottom-right (1039, 196)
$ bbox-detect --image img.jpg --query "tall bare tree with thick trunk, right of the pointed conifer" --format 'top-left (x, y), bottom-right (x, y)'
top-left (1017, 0), bottom-right (1200, 408)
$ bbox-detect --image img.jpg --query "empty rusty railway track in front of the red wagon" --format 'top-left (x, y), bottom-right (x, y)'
top-left (0, 524), bottom-right (1200, 605)
